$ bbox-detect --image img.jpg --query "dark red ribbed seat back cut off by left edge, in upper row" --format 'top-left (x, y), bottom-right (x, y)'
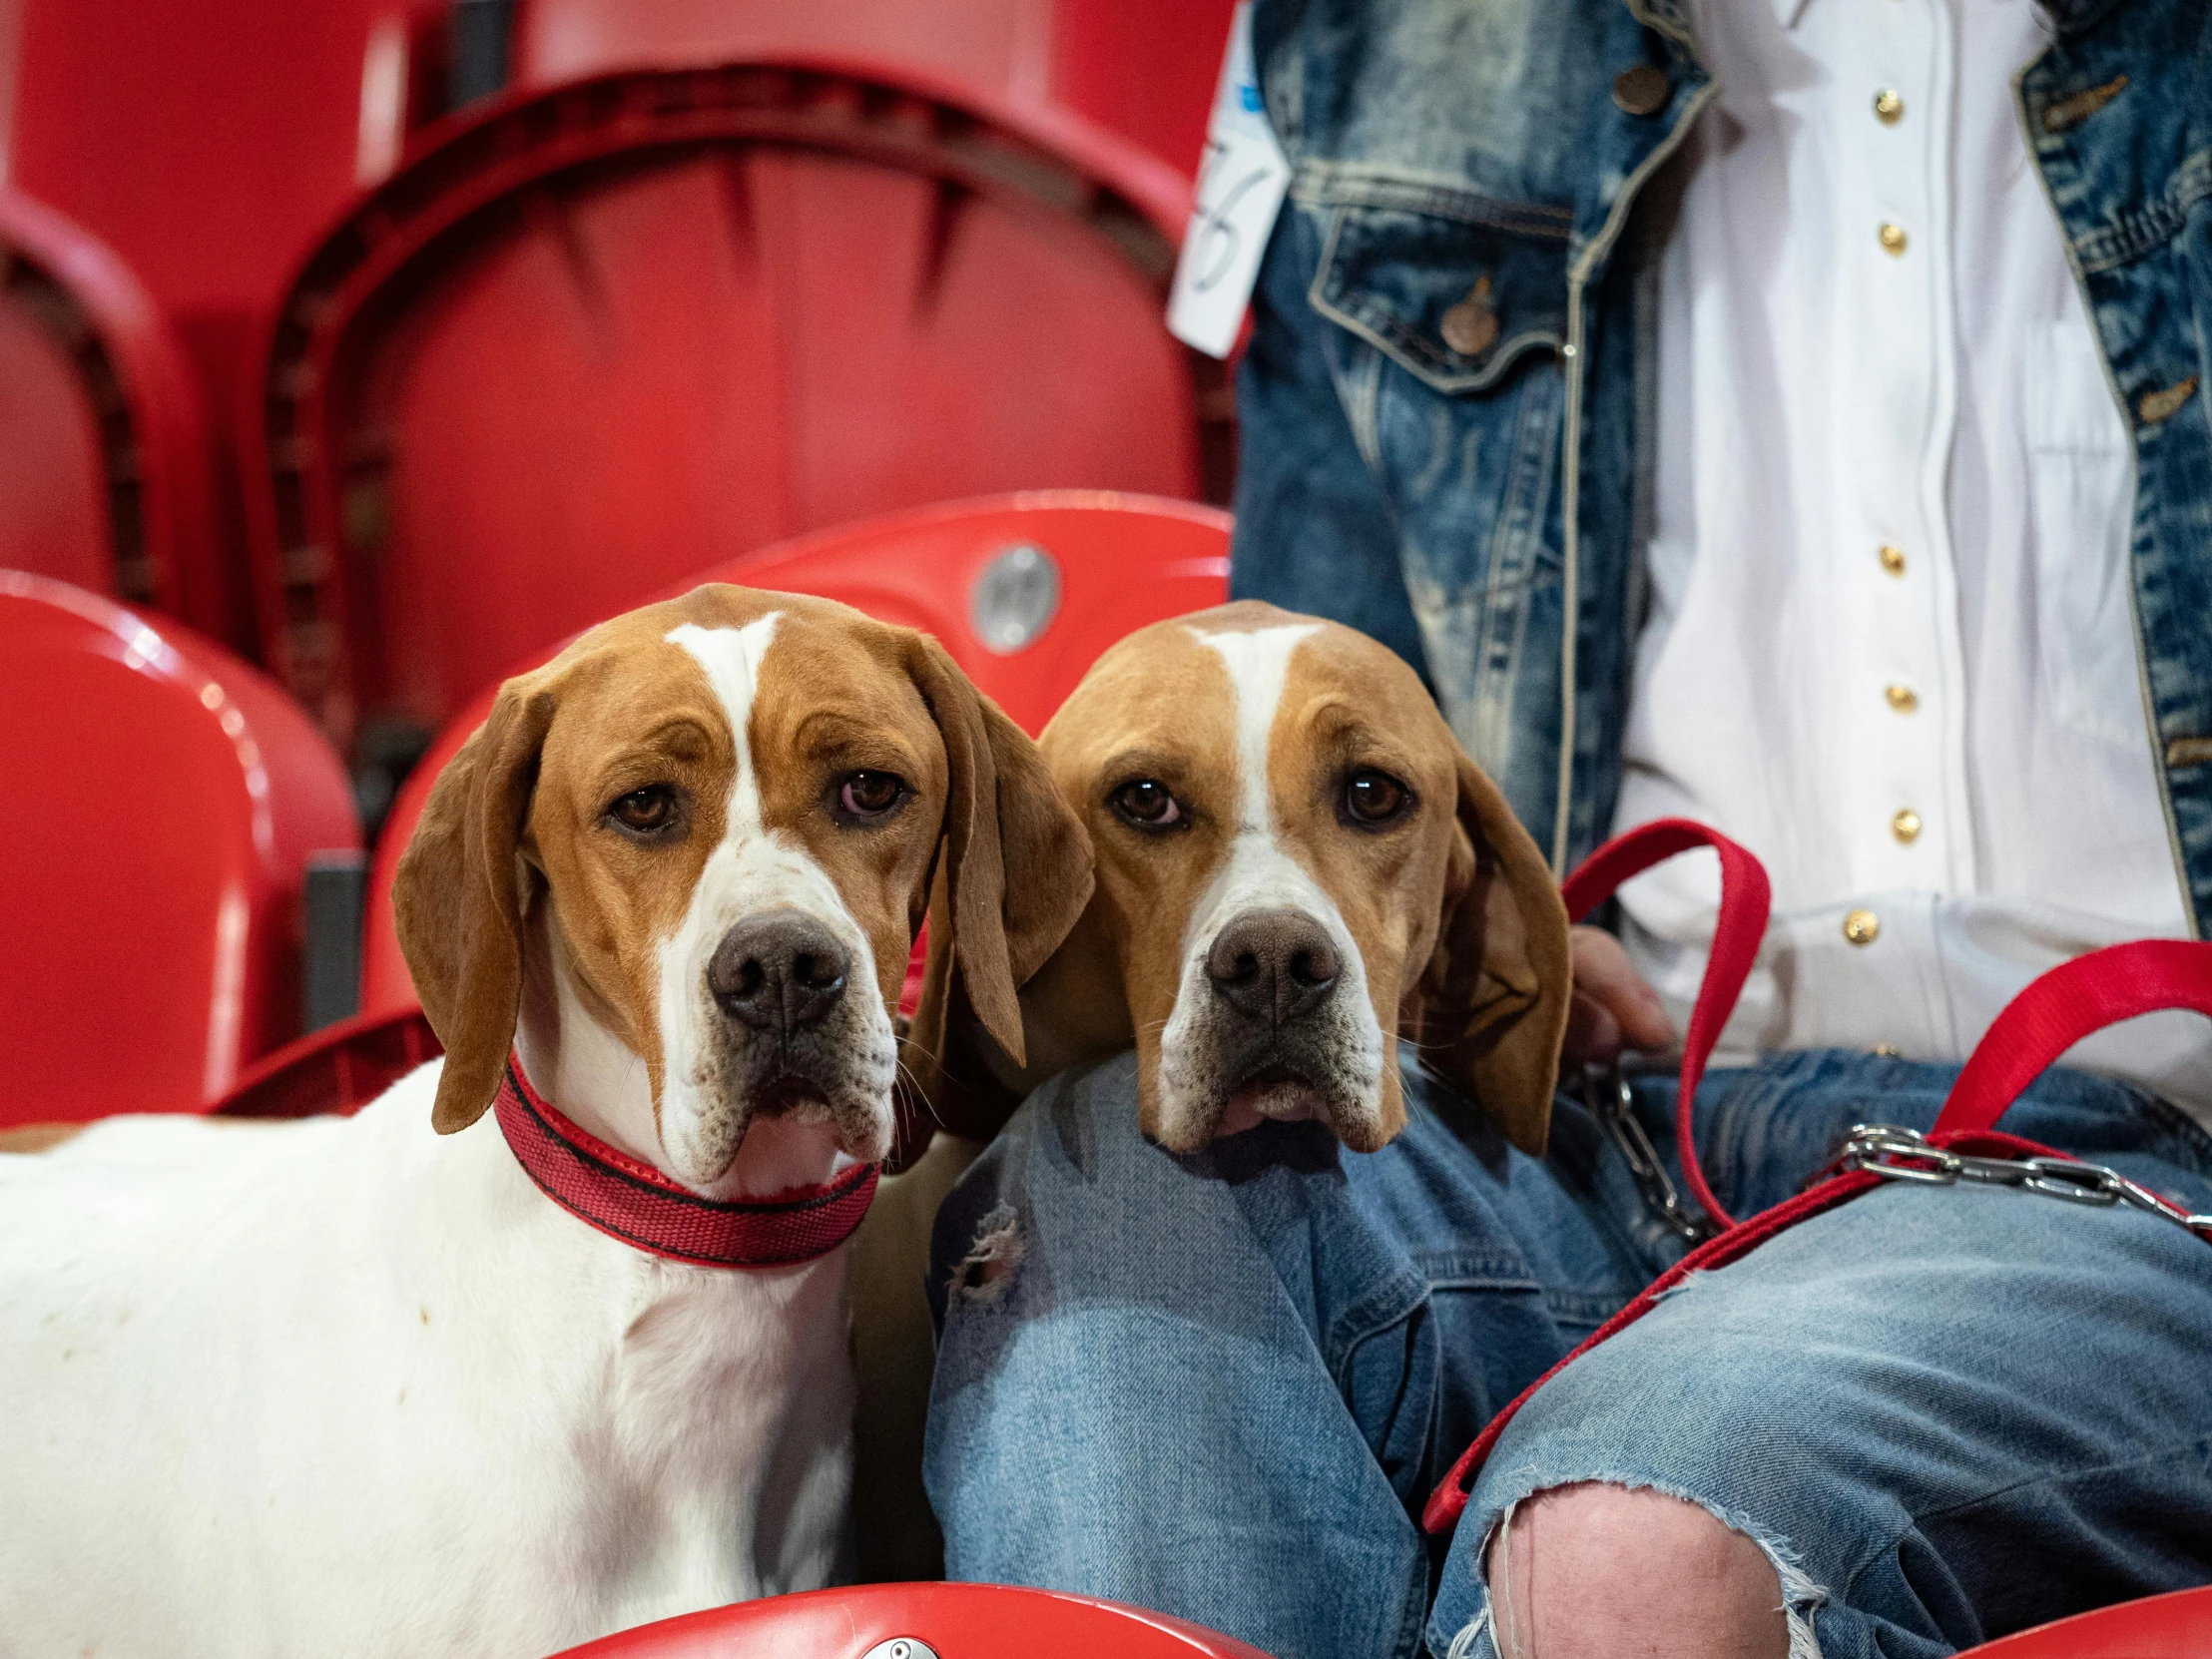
top-left (0, 188), bottom-right (226, 631)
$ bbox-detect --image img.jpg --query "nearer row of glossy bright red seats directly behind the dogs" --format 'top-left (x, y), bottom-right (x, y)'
top-left (0, 491), bottom-right (1228, 1126)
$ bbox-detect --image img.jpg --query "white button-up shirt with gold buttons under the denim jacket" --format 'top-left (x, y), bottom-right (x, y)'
top-left (1615, 0), bottom-right (2212, 1117)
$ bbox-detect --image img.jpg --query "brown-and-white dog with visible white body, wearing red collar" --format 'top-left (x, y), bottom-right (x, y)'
top-left (0, 588), bottom-right (1090, 1659)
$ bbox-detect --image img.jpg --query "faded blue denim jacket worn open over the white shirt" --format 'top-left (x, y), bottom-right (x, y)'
top-left (1232, 0), bottom-right (2212, 935)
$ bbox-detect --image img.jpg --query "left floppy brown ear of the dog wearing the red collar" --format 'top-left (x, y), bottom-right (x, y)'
top-left (391, 675), bottom-right (555, 1135)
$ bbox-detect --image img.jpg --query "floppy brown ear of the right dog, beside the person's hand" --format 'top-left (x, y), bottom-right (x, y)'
top-left (1415, 755), bottom-right (1575, 1155)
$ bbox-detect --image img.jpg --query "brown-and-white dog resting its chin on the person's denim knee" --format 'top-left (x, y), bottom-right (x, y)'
top-left (918, 602), bottom-right (1573, 1153)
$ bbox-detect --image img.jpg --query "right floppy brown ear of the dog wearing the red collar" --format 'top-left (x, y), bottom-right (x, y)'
top-left (907, 635), bottom-right (1093, 1115)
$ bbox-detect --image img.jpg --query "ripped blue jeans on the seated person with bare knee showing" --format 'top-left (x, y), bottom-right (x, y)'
top-left (924, 1051), bottom-right (2212, 1659)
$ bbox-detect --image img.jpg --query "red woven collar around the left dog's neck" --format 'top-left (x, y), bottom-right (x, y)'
top-left (491, 1057), bottom-right (876, 1268)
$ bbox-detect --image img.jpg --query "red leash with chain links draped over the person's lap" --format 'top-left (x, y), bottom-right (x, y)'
top-left (1420, 819), bottom-right (2212, 1533)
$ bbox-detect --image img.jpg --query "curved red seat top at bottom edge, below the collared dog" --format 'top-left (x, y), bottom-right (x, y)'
top-left (541, 1584), bottom-right (1268, 1659)
